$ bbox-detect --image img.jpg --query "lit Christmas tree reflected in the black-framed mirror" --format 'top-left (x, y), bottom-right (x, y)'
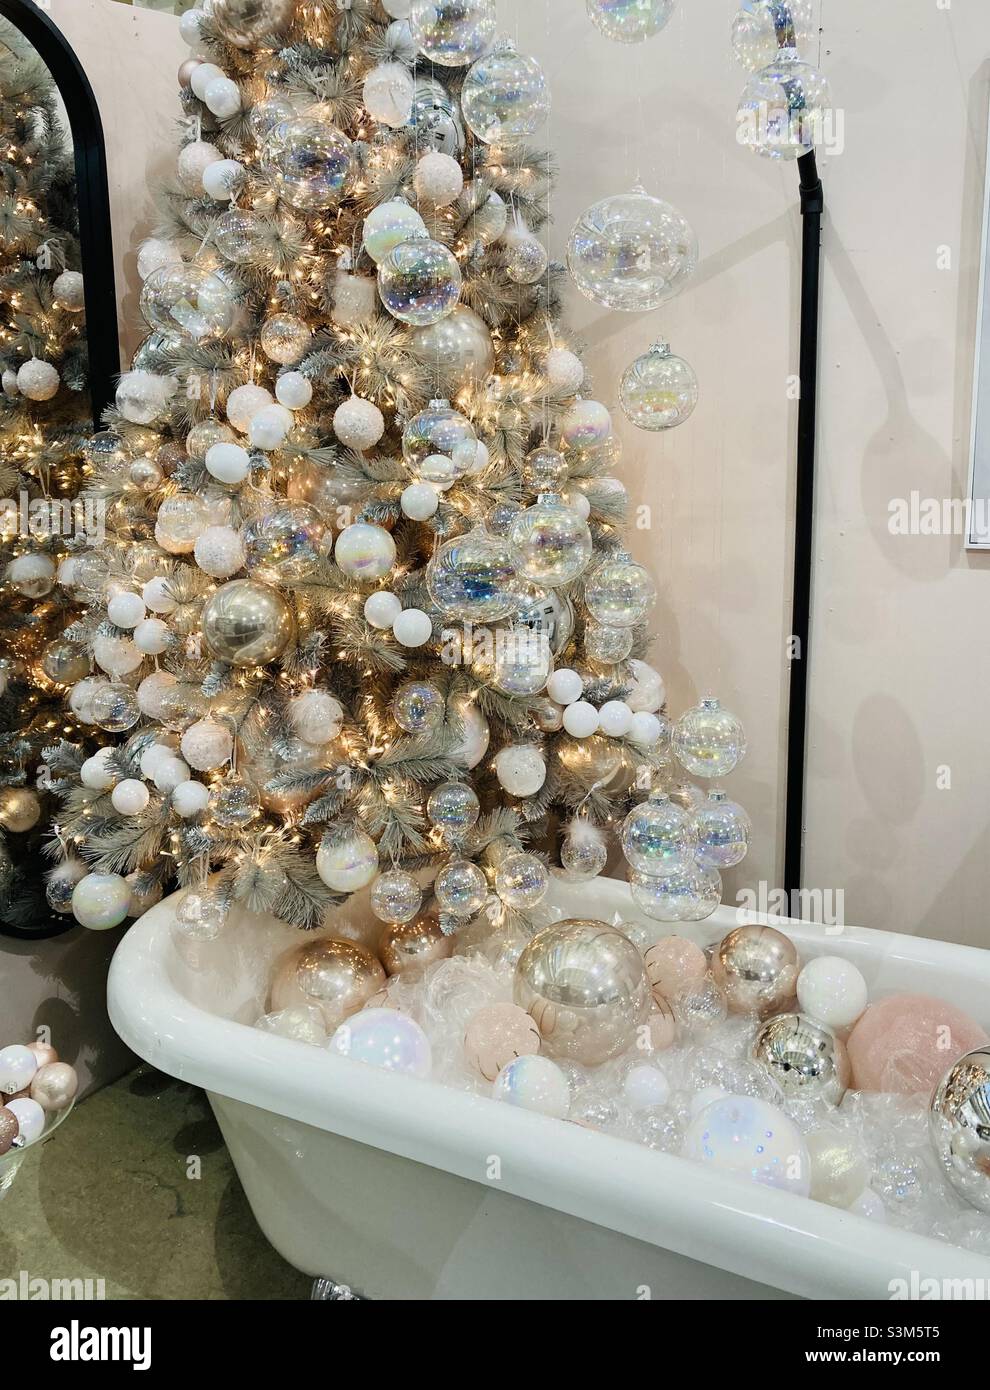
top-left (0, 21), bottom-right (92, 930)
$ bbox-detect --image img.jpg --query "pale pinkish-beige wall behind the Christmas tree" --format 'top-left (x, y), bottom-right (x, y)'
top-left (42, 0), bottom-right (990, 942)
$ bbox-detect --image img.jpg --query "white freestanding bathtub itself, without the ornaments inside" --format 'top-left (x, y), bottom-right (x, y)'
top-left (108, 880), bottom-right (990, 1300)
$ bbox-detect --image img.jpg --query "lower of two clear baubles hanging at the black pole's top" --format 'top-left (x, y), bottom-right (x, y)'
top-left (736, 49), bottom-right (831, 160)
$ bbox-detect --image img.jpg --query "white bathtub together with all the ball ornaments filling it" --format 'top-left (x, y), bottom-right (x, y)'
top-left (110, 878), bottom-right (990, 1300)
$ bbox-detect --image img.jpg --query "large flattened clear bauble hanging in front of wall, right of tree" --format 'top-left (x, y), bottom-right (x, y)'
top-left (567, 185), bottom-right (698, 314)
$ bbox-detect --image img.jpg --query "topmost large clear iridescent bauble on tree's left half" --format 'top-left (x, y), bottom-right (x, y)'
top-left (261, 114), bottom-right (355, 213)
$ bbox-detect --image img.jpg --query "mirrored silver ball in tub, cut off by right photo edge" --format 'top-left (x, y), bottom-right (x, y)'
top-left (929, 1048), bottom-right (990, 1212)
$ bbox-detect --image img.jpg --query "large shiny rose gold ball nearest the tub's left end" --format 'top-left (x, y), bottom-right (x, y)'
top-left (270, 937), bottom-right (385, 1030)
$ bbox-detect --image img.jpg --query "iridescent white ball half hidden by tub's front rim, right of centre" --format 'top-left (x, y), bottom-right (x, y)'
top-left (681, 1095), bottom-right (811, 1197)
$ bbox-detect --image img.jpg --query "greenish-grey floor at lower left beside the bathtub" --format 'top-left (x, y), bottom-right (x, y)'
top-left (0, 1066), bottom-right (310, 1300)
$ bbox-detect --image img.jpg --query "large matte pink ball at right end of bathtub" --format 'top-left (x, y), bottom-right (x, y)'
top-left (847, 994), bottom-right (987, 1095)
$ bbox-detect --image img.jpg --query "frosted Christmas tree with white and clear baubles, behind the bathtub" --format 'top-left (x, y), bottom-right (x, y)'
top-left (50, 0), bottom-right (744, 934)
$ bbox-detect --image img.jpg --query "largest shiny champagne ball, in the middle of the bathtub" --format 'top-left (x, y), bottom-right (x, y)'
top-left (513, 919), bottom-right (651, 1066)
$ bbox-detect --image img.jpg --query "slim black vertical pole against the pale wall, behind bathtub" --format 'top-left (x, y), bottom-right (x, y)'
top-left (784, 150), bottom-right (825, 894)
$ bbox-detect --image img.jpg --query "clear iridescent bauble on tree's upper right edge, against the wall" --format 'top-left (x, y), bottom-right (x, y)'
top-left (460, 39), bottom-right (551, 145)
